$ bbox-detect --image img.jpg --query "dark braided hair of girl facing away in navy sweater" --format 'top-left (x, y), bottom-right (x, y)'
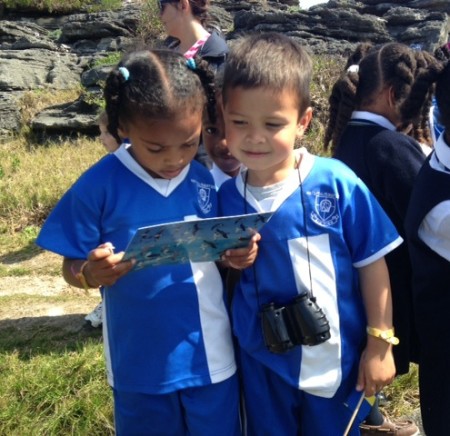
top-left (324, 43), bottom-right (441, 149)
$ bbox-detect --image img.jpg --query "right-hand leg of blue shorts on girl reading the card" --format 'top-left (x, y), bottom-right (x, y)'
top-left (180, 374), bottom-right (241, 436)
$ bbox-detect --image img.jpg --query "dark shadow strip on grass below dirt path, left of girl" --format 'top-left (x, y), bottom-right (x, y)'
top-left (0, 313), bottom-right (102, 360)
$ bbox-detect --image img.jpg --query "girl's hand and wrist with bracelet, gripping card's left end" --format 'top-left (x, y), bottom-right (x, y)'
top-left (63, 242), bottom-right (133, 289)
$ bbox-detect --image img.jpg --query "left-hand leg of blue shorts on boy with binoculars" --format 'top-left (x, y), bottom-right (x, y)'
top-left (240, 351), bottom-right (298, 436)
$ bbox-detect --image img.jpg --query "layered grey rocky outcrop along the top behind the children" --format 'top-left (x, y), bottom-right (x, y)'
top-left (0, 0), bottom-right (450, 137)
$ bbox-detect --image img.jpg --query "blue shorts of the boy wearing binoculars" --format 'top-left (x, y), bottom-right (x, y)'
top-left (240, 350), bottom-right (371, 436)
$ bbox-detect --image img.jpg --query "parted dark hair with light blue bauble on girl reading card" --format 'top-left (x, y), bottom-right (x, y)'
top-left (103, 50), bottom-right (215, 141)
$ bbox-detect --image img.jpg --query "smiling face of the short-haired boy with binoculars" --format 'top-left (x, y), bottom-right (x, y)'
top-left (224, 87), bottom-right (312, 185)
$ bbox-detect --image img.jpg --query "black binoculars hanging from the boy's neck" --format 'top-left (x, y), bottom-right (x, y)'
top-left (260, 292), bottom-right (330, 353)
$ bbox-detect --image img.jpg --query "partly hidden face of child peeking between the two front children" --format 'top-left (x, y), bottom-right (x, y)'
top-left (202, 104), bottom-right (241, 177)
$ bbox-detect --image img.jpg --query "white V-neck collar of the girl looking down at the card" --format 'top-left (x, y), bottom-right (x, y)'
top-left (114, 144), bottom-right (190, 197)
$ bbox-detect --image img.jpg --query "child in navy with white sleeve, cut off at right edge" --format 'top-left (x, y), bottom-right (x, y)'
top-left (405, 58), bottom-right (450, 436)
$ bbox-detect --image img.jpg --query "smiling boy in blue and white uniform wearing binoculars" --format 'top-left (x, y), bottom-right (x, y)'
top-left (219, 33), bottom-right (401, 436)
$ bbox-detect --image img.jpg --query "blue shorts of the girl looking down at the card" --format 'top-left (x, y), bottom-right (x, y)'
top-left (113, 374), bottom-right (241, 436)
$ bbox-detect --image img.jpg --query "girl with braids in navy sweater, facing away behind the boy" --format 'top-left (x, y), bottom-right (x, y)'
top-left (324, 43), bottom-right (438, 436)
